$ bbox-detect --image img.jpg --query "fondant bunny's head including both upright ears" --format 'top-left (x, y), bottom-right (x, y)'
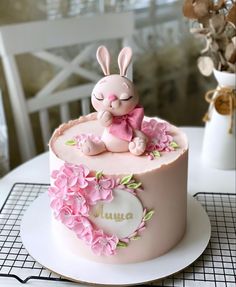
top-left (92, 46), bottom-right (138, 116)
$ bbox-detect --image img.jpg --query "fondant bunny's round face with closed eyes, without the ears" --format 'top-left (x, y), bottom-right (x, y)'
top-left (92, 75), bottom-right (138, 116)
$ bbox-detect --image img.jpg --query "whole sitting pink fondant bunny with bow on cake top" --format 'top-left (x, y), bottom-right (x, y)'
top-left (81, 46), bottom-right (146, 155)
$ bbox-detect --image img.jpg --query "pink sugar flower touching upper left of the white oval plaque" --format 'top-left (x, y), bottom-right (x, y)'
top-left (85, 177), bottom-right (116, 205)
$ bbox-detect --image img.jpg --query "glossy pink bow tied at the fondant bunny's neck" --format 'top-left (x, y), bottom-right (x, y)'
top-left (109, 106), bottom-right (144, 142)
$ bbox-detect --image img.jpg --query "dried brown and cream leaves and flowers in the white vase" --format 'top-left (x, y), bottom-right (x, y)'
top-left (183, 0), bottom-right (236, 76)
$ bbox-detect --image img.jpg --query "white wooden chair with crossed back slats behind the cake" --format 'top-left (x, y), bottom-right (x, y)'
top-left (0, 12), bottom-right (134, 161)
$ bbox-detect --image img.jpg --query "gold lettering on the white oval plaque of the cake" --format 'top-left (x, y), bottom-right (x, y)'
top-left (93, 204), bottom-right (134, 222)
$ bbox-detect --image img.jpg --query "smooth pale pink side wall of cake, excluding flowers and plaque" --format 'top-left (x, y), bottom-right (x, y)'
top-left (52, 151), bottom-right (188, 264)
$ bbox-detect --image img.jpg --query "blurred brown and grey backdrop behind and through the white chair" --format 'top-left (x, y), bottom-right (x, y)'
top-left (0, 0), bottom-right (216, 175)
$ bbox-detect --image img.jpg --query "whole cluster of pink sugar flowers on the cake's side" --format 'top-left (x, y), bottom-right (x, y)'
top-left (49, 164), bottom-right (119, 255)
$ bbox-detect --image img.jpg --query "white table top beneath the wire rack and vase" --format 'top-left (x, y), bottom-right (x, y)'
top-left (0, 127), bottom-right (235, 287)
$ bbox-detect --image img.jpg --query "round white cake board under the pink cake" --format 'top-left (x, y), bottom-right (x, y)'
top-left (21, 193), bottom-right (211, 285)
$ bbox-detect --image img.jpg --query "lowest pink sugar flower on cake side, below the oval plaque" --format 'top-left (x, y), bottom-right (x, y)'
top-left (91, 230), bottom-right (119, 256)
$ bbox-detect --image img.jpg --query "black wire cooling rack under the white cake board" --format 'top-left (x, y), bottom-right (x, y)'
top-left (0, 183), bottom-right (236, 287)
